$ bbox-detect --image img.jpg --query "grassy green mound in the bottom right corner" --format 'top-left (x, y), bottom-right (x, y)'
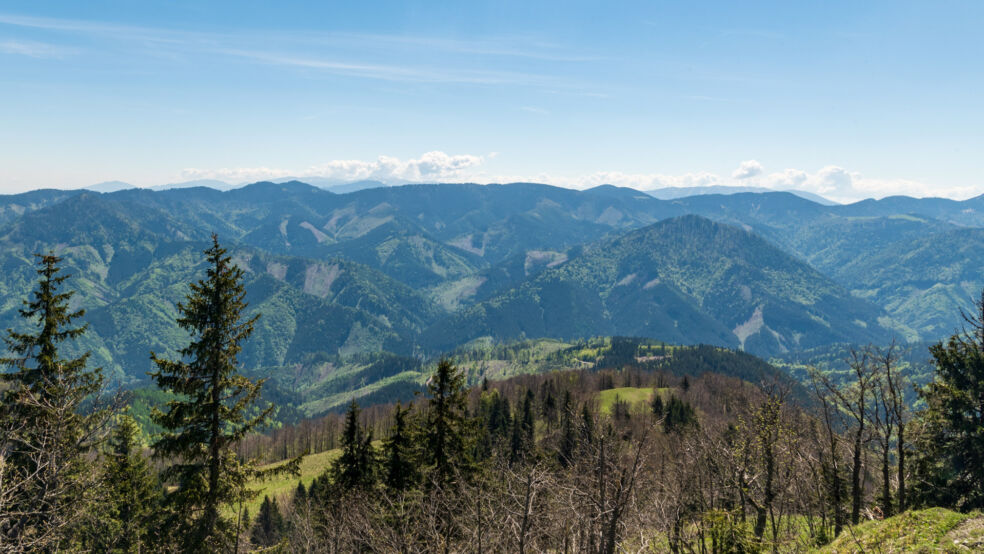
top-left (820, 508), bottom-right (984, 554)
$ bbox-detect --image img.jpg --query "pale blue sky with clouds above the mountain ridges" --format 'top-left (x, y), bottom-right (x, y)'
top-left (0, 0), bottom-right (984, 201)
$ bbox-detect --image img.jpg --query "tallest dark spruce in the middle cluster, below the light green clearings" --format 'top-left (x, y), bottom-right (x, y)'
top-left (423, 358), bottom-right (472, 483)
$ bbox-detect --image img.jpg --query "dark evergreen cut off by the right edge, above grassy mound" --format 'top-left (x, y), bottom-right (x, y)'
top-left (916, 292), bottom-right (984, 510)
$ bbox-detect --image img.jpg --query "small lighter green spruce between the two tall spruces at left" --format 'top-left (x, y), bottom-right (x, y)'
top-left (87, 413), bottom-right (161, 552)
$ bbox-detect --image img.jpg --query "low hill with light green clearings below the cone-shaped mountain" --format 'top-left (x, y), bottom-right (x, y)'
top-left (254, 337), bottom-right (807, 417)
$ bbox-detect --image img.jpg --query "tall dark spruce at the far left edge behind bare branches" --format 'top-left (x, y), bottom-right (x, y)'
top-left (0, 253), bottom-right (108, 551)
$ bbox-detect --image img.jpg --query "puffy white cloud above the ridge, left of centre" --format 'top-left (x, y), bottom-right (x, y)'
top-left (181, 151), bottom-right (485, 184)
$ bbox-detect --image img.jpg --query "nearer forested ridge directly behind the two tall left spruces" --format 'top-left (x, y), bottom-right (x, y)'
top-left (0, 197), bottom-right (438, 382)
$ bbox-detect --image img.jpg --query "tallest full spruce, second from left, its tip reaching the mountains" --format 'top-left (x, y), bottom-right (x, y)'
top-left (151, 235), bottom-right (273, 552)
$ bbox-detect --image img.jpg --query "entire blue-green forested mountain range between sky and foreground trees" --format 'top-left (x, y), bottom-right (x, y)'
top-left (0, 181), bottom-right (984, 381)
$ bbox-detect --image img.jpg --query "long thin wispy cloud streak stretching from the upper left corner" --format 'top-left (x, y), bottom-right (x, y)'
top-left (0, 13), bottom-right (597, 90)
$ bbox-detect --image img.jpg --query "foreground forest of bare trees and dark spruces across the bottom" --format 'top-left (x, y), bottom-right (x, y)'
top-left (0, 236), bottom-right (984, 553)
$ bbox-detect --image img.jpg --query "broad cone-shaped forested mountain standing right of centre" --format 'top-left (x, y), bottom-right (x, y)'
top-left (422, 216), bottom-right (889, 354)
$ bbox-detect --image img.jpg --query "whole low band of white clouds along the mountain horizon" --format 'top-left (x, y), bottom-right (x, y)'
top-left (180, 151), bottom-right (968, 202)
